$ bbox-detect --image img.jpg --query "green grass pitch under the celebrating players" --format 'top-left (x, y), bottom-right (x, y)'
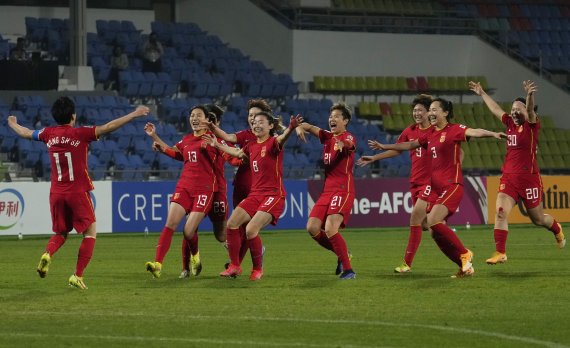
top-left (0, 226), bottom-right (570, 347)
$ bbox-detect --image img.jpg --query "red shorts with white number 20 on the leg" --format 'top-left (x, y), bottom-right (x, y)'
top-left (499, 174), bottom-right (542, 209)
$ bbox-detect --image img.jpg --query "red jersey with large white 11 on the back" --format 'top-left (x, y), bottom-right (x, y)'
top-left (32, 125), bottom-right (97, 193)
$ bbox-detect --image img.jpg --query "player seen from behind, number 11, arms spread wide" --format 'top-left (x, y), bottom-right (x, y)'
top-left (8, 97), bottom-right (149, 290)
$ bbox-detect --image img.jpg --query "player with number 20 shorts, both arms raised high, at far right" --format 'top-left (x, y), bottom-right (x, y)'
top-left (469, 81), bottom-right (566, 265)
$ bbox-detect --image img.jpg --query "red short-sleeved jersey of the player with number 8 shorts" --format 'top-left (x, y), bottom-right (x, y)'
top-left (243, 137), bottom-right (285, 196)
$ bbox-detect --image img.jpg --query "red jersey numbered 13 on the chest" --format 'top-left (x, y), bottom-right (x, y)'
top-left (175, 134), bottom-right (219, 193)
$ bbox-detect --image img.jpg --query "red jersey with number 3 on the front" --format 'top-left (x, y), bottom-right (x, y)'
top-left (418, 123), bottom-right (467, 193)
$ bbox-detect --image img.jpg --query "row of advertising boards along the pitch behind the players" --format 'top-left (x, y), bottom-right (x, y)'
top-left (7, 176), bottom-right (570, 235)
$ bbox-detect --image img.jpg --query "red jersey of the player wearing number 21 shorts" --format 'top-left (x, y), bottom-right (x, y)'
top-left (319, 129), bottom-right (356, 193)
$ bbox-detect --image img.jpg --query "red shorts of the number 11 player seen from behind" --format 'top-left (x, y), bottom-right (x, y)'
top-left (49, 192), bottom-right (95, 234)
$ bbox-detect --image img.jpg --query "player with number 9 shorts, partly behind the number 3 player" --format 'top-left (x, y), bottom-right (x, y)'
top-left (356, 94), bottom-right (435, 273)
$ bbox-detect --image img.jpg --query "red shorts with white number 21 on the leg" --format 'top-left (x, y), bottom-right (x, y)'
top-left (309, 192), bottom-right (354, 228)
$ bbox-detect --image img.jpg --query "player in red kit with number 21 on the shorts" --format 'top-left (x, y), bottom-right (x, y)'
top-left (297, 103), bottom-right (356, 279)
